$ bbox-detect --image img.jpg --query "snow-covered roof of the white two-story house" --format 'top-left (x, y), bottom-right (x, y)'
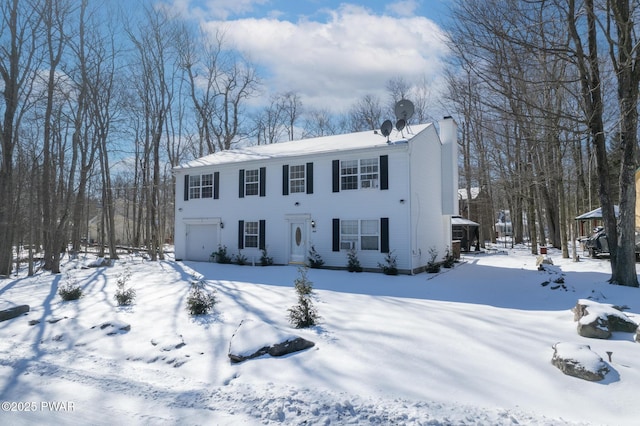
top-left (174, 123), bottom-right (433, 170)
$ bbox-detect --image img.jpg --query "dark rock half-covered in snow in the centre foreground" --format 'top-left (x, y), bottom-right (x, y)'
top-left (229, 319), bottom-right (315, 362)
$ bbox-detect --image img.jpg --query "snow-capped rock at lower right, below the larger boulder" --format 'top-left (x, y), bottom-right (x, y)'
top-left (551, 343), bottom-right (609, 382)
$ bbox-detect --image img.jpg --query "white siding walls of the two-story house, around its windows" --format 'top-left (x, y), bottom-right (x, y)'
top-left (175, 121), bottom-right (451, 271)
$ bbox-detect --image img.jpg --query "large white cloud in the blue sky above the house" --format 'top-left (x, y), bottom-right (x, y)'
top-left (205, 1), bottom-right (447, 111)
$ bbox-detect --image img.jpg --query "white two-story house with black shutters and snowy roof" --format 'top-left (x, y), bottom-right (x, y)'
top-left (174, 117), bottom-right (458, 273)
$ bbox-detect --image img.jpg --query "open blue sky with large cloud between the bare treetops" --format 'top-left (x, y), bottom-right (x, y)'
top-left (158, 0), bottom-right (451, 112)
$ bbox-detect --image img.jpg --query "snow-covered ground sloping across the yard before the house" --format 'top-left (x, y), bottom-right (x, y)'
top-left (0, 248), bottom-right (640, 425)
